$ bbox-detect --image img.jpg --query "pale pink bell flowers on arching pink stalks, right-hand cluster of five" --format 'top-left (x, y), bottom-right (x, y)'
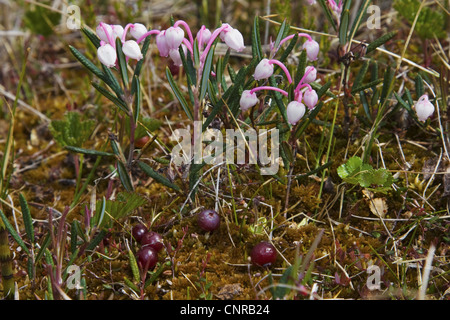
top-left (240, 33), bottom-right (319, 125)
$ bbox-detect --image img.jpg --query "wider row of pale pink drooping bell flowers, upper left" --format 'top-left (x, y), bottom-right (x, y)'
top-left (96, 20), bottom-right (245, 68)
